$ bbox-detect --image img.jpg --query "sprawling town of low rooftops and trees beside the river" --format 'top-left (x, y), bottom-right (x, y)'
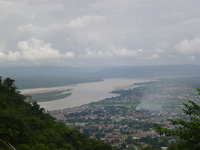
top-left (48, 78), bottom-right (200, 150)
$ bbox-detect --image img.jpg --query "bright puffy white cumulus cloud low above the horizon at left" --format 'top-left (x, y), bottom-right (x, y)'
top-left (0, 38), bottom-right (75, 62)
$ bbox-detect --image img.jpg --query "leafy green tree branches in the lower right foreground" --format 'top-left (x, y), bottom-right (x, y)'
top-left (154, 89), bottom-right (200, 150)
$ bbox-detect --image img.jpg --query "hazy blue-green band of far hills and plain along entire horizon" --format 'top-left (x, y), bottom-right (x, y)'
top-left (0, 65), bottom-right (200, 89)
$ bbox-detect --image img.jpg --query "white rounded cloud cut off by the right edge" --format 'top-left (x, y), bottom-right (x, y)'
top-left (175, 39), bottom-right (200, 55)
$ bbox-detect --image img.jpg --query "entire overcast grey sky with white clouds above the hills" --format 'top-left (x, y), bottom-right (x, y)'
top-left (0, 0), bottom-right (200, 67)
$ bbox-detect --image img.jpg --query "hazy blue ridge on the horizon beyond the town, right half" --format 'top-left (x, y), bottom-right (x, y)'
top-left (95, 65), bottom-right (200, 78)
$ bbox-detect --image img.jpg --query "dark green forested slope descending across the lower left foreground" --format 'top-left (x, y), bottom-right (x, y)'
top-left (0, 77), bottom-right (112, 150)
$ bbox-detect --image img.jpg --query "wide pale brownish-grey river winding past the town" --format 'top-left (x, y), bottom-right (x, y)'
top-left (21, 78), bottom-right (153, 111)
